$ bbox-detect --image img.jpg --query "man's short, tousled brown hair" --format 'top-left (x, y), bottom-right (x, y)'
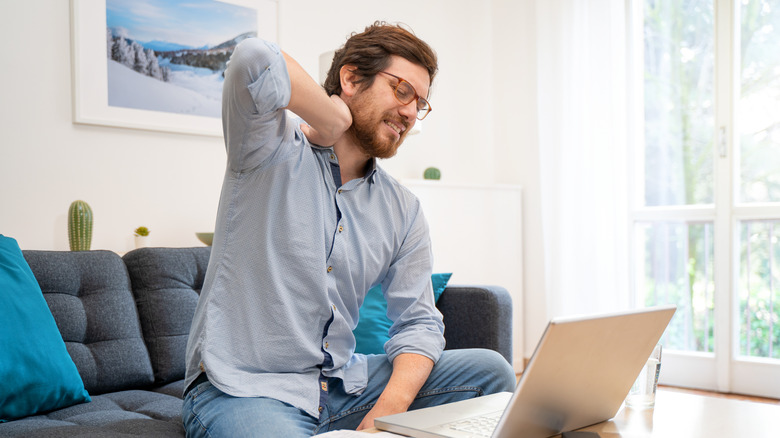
top-left (323, 21), bottom-right (439, 96)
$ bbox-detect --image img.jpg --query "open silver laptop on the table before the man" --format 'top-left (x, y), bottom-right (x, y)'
top-left (374, 306), bottom-right (676, 438)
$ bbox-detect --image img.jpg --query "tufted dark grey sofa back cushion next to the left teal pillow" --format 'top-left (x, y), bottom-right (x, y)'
top-left (23, 250), bottom-right (154, 395)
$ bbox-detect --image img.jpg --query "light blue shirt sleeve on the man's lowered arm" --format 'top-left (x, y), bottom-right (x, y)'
top-left (382, 202), bottom-right (445, 362)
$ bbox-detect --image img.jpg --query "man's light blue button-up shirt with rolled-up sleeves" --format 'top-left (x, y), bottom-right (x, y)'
top-left (186, 39), bottom-right (444, 417)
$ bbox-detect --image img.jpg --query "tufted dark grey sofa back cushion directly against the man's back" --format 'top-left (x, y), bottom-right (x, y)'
top-left (123, 246), bottom-right (211, 384)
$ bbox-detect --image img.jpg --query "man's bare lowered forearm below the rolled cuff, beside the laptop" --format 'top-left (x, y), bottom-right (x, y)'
top-left (358, 353), bottom-right (433, 429)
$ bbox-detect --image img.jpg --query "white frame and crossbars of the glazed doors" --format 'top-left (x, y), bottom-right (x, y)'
top-left (626, 0), bottom-right (780, 398)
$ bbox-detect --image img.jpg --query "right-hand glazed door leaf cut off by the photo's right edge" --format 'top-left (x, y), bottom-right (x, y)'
top-left (731, 0), bottom-right (780, 397)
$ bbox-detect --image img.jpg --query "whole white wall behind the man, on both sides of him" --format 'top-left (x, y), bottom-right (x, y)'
top-left (0, 0), bottom-right (547, 356)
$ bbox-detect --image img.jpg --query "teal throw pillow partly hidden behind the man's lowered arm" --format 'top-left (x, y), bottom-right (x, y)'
top-left (352, 273), bottom-right (452, 354)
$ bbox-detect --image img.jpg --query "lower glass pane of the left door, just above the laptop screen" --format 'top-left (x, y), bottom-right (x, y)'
top-left (635, 222), bottom-right (715, 352)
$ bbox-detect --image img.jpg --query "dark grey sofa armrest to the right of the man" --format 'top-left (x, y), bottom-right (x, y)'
top-left (436, 286), bottom-right (512, 364)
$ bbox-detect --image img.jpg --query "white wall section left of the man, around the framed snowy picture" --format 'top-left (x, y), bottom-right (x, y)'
top-left (0, 0), bottom-right (225, 252)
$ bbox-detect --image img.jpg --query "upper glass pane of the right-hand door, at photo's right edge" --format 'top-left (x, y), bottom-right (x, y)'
top-left (737, 0), bottom-right (780, 202)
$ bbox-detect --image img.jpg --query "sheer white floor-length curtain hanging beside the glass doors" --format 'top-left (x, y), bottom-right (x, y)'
top-left (536, 0), bottom-right (631, 316)
